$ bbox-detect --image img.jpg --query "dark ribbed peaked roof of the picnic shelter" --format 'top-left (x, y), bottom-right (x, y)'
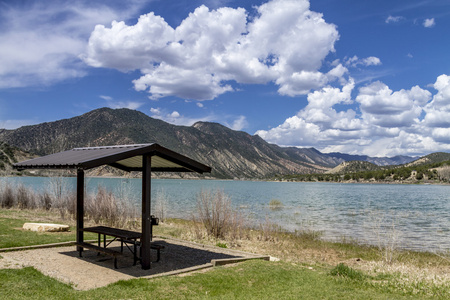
top-left (14, 144), bottom-right (211, 173)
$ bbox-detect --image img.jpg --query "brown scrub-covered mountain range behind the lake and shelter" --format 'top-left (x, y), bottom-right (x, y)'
top-left (0, 108), bottom-right (417, 178)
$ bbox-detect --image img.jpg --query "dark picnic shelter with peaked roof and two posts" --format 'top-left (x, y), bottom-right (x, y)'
top-left (13, 143), bottom-right (211, 269)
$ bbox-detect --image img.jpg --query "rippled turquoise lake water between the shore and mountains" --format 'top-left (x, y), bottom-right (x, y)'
top-left (0, 177), bottom-right (450, 252)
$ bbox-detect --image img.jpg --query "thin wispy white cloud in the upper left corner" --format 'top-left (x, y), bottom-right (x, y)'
top-left (0, 0), bottom-right (144, 88)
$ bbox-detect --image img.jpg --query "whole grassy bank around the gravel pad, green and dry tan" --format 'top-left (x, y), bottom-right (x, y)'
top-left (0, 209), bottom-right (450, 299)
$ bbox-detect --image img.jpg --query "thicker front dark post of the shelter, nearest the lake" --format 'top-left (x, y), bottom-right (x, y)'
top-left (141, 155), bottom-right (152, 270)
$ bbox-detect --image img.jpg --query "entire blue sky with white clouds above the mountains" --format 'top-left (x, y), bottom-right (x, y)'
top-left (0, 0), bottom-right (450, 156)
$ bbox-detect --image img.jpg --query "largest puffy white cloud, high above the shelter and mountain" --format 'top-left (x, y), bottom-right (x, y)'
top-left (83, 0), bottom-right (343, 100)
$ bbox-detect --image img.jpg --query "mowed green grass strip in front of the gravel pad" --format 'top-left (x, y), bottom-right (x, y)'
top-left (0, 261), bottom-right (420, 299)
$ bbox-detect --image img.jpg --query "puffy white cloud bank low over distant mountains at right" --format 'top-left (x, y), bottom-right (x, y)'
top-left (256, 75), bottom-right (450, 156)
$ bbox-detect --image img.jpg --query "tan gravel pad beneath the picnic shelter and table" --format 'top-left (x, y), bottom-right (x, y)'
top-left (0, 239), bottom-right (255, 290)
